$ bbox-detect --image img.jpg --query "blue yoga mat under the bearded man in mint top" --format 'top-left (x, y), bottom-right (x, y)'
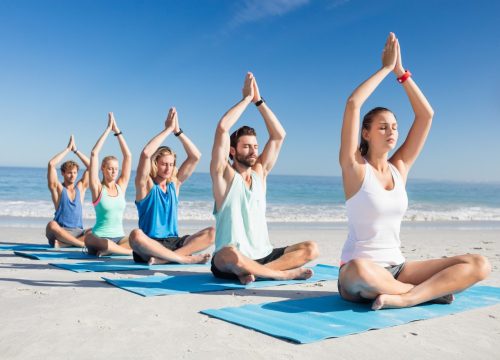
top-left (103, 264), bottom-right (339, 296)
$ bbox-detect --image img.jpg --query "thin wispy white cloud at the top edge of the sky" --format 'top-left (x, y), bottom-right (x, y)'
top-left (231, 0), bottom-right (309, 26)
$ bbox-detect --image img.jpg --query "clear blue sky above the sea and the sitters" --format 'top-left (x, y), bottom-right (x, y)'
top-left (0, 0), bottom-right (500, 182)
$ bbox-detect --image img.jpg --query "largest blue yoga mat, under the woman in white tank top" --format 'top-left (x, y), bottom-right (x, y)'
top-left (201, 286), bottom-right (500, 344)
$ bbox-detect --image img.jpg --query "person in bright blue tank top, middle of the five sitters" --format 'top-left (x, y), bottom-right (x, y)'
top-left (130, 108), bottom-right (215, 264)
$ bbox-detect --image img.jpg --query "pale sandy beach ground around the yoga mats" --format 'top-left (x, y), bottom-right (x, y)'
top-left (0, 222), bottom-right (500, 359)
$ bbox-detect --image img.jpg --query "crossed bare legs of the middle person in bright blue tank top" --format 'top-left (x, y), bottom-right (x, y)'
top-left (129, 227), bottom-right (215, 265)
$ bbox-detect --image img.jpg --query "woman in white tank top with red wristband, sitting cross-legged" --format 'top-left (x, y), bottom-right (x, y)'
top-left (338, 33), bottom-right (491, 310)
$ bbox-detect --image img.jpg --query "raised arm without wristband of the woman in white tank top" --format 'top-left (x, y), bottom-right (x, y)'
top-left (339, 33), bottom-right (397, 169)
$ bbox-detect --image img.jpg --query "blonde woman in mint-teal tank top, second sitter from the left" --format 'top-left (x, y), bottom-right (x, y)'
top-left (85, 113), bottom-right (132, 256)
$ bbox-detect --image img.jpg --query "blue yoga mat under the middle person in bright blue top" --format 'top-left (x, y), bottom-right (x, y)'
top-left (50, 260), bottom-right (208, 272)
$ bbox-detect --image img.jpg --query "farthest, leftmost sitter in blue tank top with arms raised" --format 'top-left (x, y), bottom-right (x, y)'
top-left (45, 135), bottom-right (89, 247)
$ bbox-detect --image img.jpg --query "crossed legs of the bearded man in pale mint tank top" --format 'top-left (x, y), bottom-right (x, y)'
top-left (213, 241), bottom-right (319, 284)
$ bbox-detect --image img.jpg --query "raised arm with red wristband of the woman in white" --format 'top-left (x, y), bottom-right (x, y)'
top-left (391, 39), bottom-right (434, 179)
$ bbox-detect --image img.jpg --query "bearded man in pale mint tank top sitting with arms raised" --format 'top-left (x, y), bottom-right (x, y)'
top-left (210, 73), bottom-right (318, 284)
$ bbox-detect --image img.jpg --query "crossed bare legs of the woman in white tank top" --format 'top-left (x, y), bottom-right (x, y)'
top-left (339, 254), bottom-right (491, 310)
